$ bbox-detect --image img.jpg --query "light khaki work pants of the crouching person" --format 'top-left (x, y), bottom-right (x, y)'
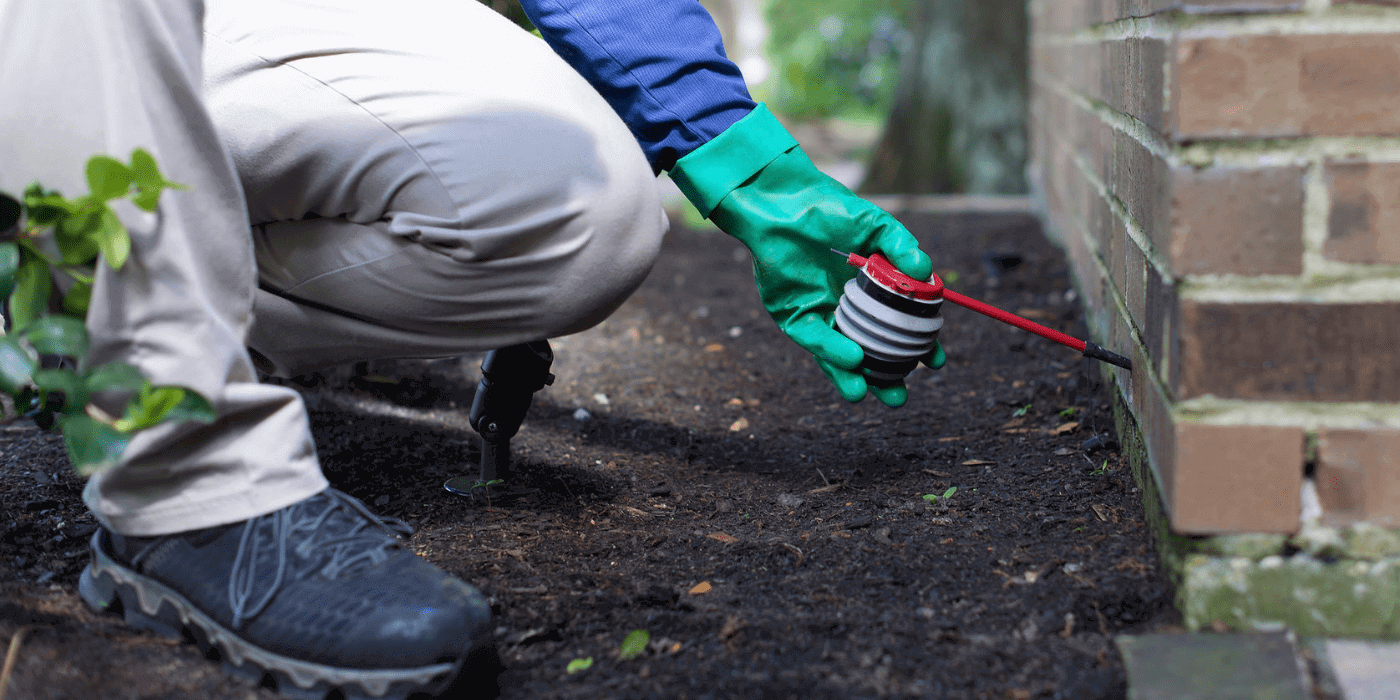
top-left (0, 0), bottom-right (666, 535)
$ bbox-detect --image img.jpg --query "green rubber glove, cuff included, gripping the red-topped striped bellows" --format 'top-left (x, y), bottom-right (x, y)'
top-left (671, 104), bottom-right (945, 407)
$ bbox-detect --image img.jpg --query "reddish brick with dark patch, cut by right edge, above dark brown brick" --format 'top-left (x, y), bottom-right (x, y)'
top-left (1323, 162), bottom-right (1400, 265)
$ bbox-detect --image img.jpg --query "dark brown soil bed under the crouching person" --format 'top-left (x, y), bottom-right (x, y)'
top-left (0, 214), bottom-right (1177, 700)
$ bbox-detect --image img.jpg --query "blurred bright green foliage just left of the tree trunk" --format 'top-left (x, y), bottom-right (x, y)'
top-left (766, 0), bottom-right (913, 120)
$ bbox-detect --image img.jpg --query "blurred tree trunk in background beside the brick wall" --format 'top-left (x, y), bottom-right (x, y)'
top-left (861, 0), bottom-right (1029, 195)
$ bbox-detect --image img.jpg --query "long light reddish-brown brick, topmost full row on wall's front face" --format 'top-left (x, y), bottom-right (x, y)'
top-left (1170, 34), bottom-right (1400, 140)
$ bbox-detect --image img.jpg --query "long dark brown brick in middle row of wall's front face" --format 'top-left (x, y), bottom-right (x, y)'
top-left (1176, 303), bottom-right (1400, 402)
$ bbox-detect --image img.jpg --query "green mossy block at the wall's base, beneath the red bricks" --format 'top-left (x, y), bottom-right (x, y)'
top-left (1179, 554), bottom-right (1400, 638)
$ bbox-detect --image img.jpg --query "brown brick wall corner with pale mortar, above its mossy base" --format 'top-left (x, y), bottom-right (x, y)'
top-left (1030, 0), bottom-right (1400, 533)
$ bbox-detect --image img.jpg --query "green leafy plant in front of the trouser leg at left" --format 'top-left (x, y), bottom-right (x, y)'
top-left (0, 148), bottom-right (214, 475)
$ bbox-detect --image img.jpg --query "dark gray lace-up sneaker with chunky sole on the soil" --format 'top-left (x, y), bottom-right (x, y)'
top-left (78, 489), bottom-right (491, 700)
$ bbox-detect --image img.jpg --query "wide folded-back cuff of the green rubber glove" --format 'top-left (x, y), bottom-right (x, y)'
top-left (671, 102), bottom-right (797, 218)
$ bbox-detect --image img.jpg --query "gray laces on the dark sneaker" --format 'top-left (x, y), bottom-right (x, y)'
top-left (228, 489), bottom-right (413, 629)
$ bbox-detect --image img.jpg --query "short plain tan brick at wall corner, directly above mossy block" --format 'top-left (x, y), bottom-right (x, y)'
top-left (1168, 421), bottom-right (1303, 535)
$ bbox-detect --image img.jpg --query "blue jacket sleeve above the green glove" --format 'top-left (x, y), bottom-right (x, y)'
top-left (521, 0), bottom-right (755, 172)
